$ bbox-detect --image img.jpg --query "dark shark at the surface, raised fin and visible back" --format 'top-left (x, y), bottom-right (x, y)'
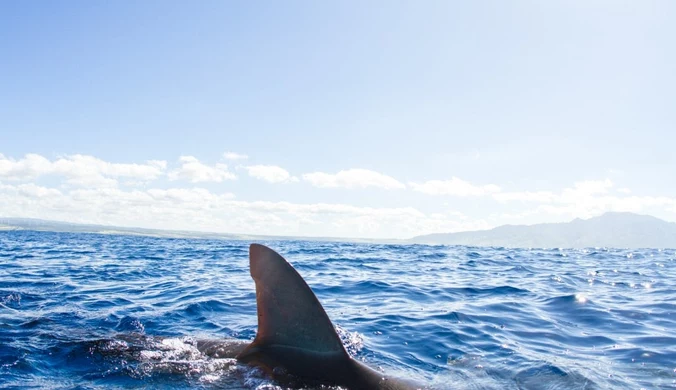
top-left (196, 244), bottom-right (426, 390)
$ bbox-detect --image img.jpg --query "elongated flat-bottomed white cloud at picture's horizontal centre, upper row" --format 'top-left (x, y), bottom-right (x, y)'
top-left (303, 169), bottom-right (406, 190)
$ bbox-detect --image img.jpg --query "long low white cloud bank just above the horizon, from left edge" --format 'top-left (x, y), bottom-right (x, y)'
top-left (0, 180), bottom-right (485, 238)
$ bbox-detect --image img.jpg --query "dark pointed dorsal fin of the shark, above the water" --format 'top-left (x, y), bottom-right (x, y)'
top-left (244, 244), bottom-right (347, 355)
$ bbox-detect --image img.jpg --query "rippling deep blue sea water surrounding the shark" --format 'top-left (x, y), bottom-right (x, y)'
top-left (0, 231), bottom-right (676, 389)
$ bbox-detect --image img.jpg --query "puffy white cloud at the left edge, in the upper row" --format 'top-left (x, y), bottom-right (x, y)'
top-left (0, 153), bottom-right (167, 186)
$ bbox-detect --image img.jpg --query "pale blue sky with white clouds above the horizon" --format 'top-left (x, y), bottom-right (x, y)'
top-left (0, 0), bottom-right (676, 238)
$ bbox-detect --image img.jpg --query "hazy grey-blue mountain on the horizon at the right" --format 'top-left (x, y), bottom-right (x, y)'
top-left (409, 212), bottom-right (676, 248)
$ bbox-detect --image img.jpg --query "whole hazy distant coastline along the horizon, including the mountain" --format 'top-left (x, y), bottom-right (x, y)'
top-left (0, 212), bottom-right (676, 248)
